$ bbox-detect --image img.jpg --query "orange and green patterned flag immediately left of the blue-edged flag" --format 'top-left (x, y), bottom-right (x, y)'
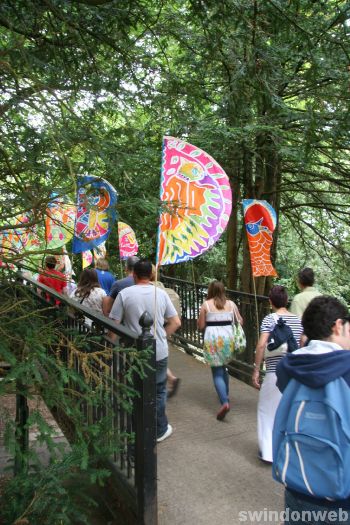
top-left (45, 194), bottom-right (76, 250)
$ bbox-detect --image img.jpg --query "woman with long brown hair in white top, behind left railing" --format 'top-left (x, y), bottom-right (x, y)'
top-left (70, 268), bottom-right (106, 326)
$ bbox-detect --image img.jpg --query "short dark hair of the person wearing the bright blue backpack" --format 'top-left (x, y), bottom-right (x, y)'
top-left (301, 295), bottom-right (348, 340)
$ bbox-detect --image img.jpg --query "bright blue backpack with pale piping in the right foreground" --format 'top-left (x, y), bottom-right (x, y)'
top-left (272, 378), bottom-right (350, 500)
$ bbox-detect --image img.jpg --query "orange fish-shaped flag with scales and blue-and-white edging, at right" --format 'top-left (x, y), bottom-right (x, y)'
top-left (242, 199), bottom-right (277, 277)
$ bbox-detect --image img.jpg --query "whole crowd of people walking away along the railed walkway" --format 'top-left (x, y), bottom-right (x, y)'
top-left (34, 256), bottom-right (350, 525)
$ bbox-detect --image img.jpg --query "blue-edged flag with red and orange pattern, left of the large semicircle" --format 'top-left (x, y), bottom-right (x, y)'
top-left (72, 176), bottom-right (117, 253)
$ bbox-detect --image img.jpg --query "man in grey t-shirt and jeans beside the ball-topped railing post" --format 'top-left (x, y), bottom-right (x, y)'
top-left (109, 260), bottom-right (181, 441)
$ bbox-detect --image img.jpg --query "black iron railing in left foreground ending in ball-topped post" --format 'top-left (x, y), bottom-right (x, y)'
top-left (17, 276), bottom-right (157, 525)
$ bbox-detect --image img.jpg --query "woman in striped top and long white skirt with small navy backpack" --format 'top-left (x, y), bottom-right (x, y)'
top-left (252, 285), bottom-right (303, 463)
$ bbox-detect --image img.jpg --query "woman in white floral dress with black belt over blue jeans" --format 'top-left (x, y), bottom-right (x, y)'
top-left (197, 281), bottom-right (243, 421)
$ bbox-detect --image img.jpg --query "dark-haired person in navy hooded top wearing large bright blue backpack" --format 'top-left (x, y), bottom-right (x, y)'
top-left (272, 296), bottom-right (350, 525)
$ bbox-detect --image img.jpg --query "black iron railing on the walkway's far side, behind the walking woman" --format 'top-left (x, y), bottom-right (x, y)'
top-left (161, 276), bottom-right (270, 382)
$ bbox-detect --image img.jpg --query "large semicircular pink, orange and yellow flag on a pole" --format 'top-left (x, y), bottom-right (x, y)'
top-left (157, 137), bottom-right (232, 265)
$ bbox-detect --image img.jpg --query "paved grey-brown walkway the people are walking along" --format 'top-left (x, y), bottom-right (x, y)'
top-left (158, 348), bottom-right (283, 525)
